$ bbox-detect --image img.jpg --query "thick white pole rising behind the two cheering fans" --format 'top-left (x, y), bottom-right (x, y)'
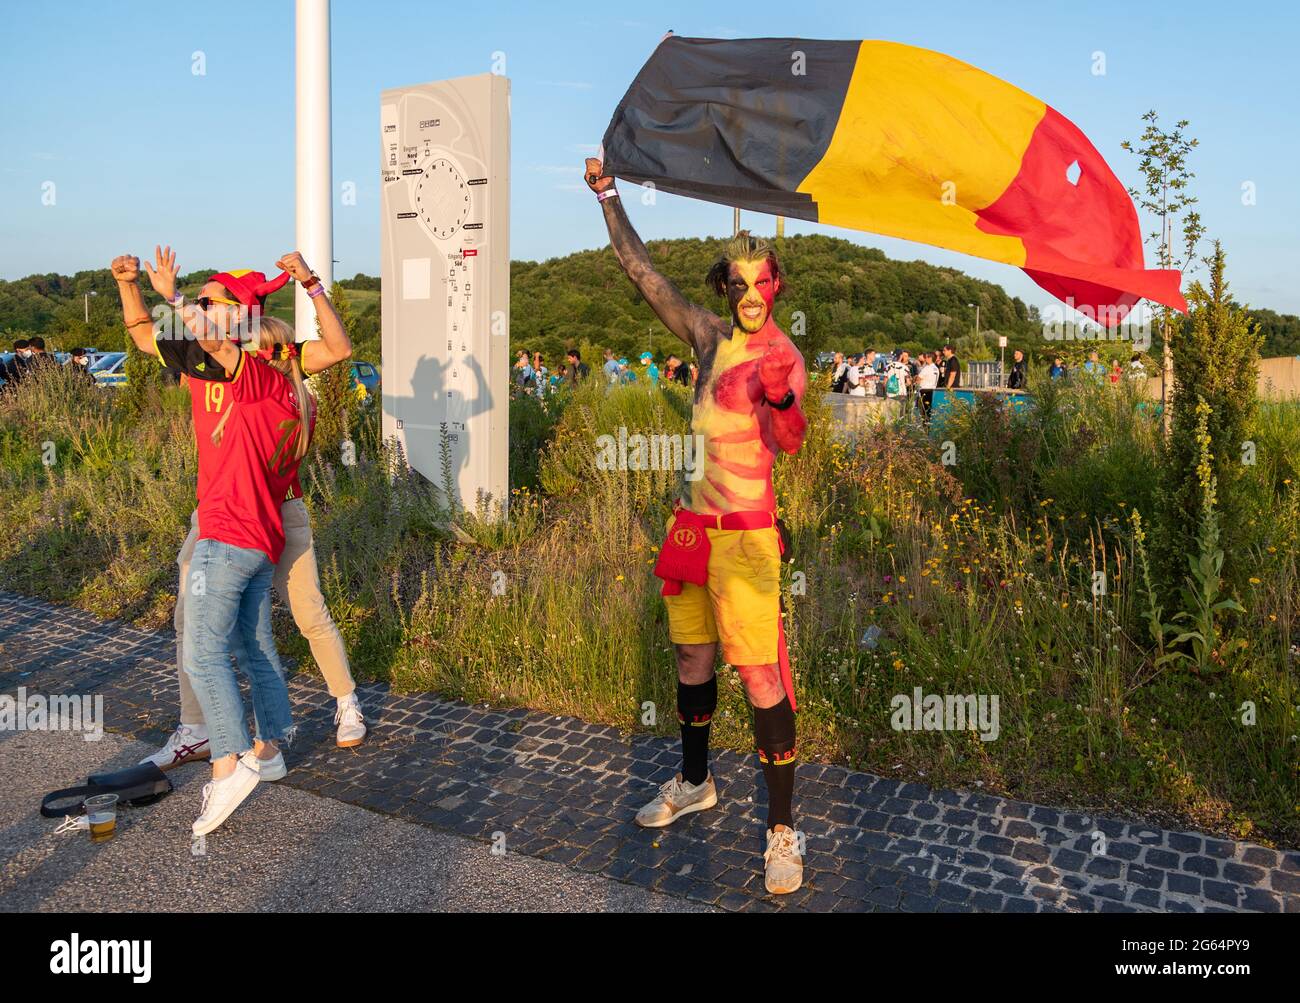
top-left (294, 0), bottom-right (334, 339)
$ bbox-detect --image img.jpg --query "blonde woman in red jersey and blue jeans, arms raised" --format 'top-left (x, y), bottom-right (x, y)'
top-left (174, 307), bottom-right (315, 835)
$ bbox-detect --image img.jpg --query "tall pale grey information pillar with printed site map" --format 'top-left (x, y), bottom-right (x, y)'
top-left (380, 73), bottom-right (510, 514)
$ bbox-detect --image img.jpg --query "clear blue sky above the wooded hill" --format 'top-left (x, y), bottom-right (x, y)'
top-left (0, 0), bottom-right (1300, 313)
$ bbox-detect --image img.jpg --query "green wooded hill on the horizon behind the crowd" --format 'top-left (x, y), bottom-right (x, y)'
top-left (0, 234), bottom-right (1300, 368)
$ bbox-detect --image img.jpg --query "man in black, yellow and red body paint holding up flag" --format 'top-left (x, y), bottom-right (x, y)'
top-left (585, 159), bottom-right (807, 895)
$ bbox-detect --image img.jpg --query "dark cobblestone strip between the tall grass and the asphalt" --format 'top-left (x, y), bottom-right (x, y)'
top-left (0, 592), bottom-right (1300, 912)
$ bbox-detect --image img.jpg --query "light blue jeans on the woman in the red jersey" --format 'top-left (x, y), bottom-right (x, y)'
top-left (181, 539), bottom-right (293, 760)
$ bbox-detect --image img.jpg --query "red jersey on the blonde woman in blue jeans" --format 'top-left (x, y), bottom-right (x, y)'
top-left (194, 352), bottom-right (316, 563)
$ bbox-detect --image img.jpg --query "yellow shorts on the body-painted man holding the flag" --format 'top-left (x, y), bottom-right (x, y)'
top-left (663, 520), bottom-right (781, 665)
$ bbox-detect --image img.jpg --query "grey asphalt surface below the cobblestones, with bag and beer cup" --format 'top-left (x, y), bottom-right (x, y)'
top-left (0, 731), bottom-right (710, 912)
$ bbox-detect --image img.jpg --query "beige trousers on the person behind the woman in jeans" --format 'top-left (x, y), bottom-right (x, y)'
top-left (176, 498), bottom-right (356, 725)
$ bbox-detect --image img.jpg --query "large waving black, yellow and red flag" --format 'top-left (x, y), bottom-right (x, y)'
top-left (603, 36), bottom-right (1187, 325)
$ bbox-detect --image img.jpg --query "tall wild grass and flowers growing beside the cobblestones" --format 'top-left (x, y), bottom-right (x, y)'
top-left (0, 363), bottom-right (1300, 844)
